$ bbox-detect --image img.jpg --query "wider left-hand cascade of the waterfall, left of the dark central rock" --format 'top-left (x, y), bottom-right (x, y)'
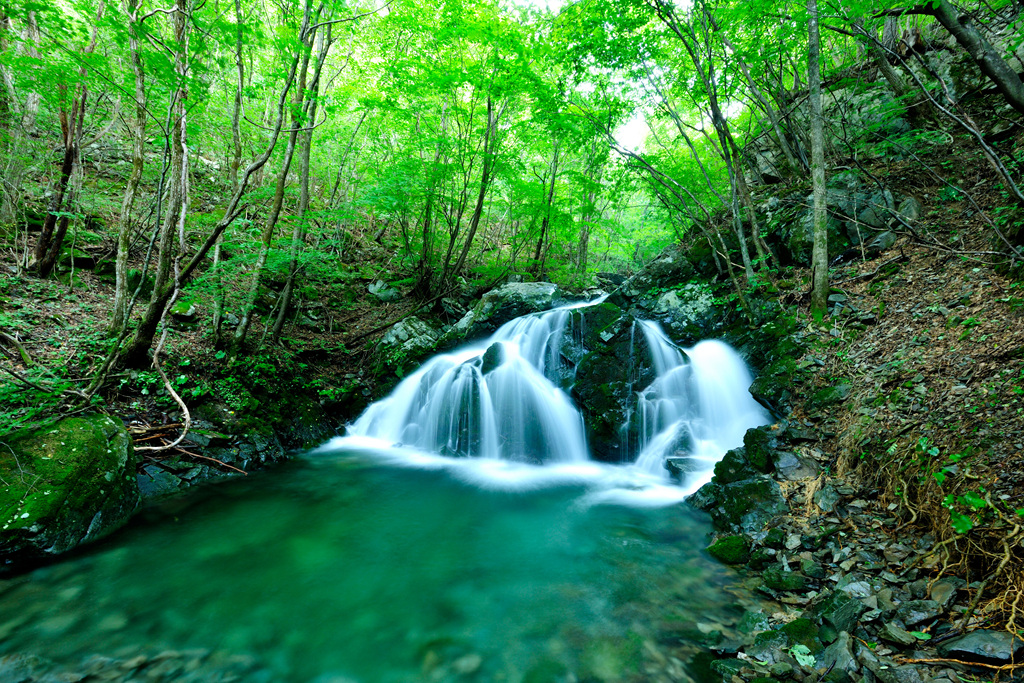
top-left (349, 308), bottom-right (589, 463)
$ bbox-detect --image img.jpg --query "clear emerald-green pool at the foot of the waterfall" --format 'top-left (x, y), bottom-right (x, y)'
top-left (0, 451), bottom-right (741, 683)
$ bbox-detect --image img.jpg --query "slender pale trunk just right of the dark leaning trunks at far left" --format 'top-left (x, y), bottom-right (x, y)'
top-left (110, 0), bottom-right (146, 334)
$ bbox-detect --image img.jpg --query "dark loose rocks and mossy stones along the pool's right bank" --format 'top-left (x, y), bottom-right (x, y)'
top-left (689, 425), bottom-right (1024, 683)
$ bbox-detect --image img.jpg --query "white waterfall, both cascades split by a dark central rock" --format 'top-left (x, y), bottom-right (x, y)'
top-left (334, 299), bottom-right (768, 503)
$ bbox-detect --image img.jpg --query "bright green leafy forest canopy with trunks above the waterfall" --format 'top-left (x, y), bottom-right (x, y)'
top-left (0, 0), bottom-right (1024, 365)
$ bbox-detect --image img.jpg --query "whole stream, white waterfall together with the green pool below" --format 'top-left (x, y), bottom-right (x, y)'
top-left (0, 301), bottom-right (767, 683)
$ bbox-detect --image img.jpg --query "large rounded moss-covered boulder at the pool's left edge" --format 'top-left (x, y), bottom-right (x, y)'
top-left (0, 415), bottom-right (140, 567)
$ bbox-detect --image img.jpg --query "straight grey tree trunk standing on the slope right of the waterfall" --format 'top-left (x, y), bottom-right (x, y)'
top-left (807, 0), bottom-right (828, 316)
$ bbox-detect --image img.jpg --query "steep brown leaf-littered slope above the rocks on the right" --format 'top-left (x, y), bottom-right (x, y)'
top-left (774, 143), bottom-right (1024, 602)
